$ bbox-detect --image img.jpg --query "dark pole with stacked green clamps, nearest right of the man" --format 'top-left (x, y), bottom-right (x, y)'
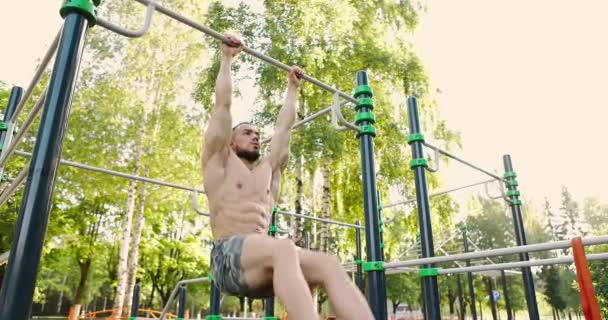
top-left (354, 71), bottom-right (387, 320)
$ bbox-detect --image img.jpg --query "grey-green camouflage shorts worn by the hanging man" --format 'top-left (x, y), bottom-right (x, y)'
top-left (211, 235), bottom-right (274, 299)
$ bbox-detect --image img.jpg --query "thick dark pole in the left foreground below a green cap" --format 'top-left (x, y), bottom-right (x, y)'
top-left (0, 7), bottom-right (89, 320)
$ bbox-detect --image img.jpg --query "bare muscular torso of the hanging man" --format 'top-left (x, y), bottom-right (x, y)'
top-left (203, 150), bottom-right (279, 239)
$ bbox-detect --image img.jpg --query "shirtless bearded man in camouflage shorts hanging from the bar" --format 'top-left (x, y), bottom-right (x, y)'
top-left (202, 34), bottom-right (373, 320)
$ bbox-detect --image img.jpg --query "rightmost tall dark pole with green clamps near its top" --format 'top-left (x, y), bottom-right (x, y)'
top-left (503, 154), bottom-right (540, 320)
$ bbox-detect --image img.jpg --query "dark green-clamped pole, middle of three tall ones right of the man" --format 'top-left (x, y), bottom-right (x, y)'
top-left (407, 97), bottom-right (441, 320)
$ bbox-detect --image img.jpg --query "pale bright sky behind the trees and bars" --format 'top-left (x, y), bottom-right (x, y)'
top-left (0, 0), bottom-right (608, 207)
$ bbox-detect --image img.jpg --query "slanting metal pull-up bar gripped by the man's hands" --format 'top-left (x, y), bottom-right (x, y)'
top-left (131, 0), bottom-right (357, 103)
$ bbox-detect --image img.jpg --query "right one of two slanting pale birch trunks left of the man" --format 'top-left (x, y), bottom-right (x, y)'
top-left (123, 179), bottom-right (148, 310)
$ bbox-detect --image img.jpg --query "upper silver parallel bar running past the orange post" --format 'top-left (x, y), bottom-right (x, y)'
top-left (384, 236), bottom-right (608, 268)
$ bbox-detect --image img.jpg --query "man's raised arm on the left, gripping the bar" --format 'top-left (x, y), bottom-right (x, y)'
top-left (201, 35), bottom-right (243, 170)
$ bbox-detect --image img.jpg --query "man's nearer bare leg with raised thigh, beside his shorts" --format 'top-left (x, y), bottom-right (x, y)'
top-left (241, 234), bottom-right (317, 320)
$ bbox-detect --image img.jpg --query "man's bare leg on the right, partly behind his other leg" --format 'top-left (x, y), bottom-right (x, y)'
top-left (299, 250), bottom-right (374, 320)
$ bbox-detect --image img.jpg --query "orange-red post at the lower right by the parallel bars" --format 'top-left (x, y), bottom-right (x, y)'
top-left (572, 238), bottom-right (601, 320)
